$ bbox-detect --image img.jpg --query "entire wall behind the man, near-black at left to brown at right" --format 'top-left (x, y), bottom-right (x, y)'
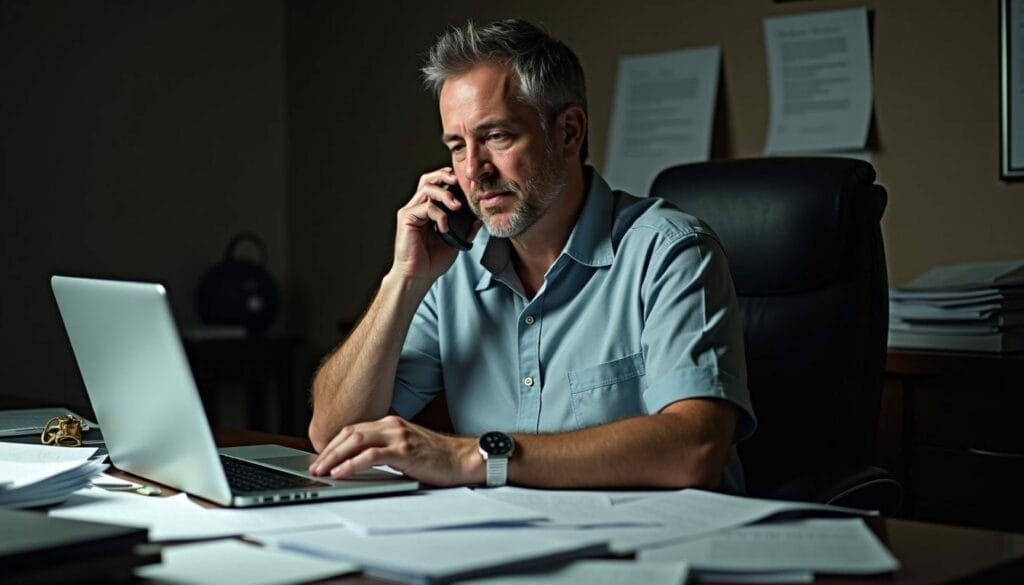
top-left (0, 0), bottom-right (1024, 430)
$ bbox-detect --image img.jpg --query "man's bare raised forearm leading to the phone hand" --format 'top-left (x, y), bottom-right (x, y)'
top-left (309, 274), bottom-right (429, 451)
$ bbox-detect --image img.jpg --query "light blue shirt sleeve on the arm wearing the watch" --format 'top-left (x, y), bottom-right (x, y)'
top-left (641, 232), bottom-right (757, 443)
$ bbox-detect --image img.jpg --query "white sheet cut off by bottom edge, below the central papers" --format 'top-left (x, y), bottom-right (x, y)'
top-left (459, 560), bottom-right (687, 585)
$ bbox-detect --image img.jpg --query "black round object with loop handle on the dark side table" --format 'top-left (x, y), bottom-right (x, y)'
top-left (196, 232), bottom-right (281, 333)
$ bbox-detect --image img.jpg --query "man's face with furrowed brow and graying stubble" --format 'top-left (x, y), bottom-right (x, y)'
top-left (440, 65), bottom-right (566, 238)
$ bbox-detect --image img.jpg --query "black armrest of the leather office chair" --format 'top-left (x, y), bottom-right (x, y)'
top-left (772, 465), bottom-right (903, 516)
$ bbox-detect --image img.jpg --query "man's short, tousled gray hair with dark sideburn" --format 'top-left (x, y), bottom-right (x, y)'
top-left (420, 18), bottom-right (589, 161)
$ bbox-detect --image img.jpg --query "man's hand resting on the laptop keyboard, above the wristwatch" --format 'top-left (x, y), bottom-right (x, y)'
top-left (309, 416), bottom-right (483, 486)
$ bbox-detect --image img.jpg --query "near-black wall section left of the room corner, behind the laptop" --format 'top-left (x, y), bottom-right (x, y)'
top-left (0, 0), bottom-right (288, 411)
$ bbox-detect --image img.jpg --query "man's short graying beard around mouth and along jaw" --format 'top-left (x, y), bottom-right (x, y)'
top-left (473, 144), bottom-right (566, 238)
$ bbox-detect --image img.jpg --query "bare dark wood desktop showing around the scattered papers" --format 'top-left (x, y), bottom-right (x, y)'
top-left (92, 430), bottom-right (1024, 585)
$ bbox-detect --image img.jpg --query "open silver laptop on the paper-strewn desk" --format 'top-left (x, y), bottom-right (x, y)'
top-left (50, 276), bottom-right (419, 507)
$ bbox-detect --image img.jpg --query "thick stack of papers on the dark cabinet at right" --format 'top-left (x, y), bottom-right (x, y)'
top-left (889, 260), bottom-right (1024, 353)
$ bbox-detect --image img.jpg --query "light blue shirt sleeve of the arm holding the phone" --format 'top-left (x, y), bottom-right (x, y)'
top-left (391, 283), bottom-right (443, 418)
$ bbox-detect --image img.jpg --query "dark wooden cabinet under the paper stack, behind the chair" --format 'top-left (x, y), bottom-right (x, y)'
top-left (879, 350), bottom-right (1024, 532)
